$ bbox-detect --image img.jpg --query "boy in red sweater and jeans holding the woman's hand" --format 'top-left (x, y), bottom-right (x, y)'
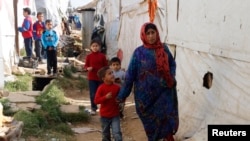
top-left (95, 66), bottom-right (122, 141)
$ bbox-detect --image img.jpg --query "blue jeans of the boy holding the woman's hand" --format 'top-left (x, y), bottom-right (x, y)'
top-left (101, 116), bottom-right (122, 141)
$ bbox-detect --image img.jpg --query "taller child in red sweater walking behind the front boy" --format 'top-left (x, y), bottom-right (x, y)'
top-left (84, 39), bottom-right (108, 115)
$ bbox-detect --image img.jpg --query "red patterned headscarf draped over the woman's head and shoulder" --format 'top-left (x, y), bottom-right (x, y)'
top-left (140, 22), bottom-right (174, 87)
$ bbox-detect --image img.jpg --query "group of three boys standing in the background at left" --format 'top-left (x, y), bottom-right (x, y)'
top-left (18, 8), bottom-right (59, 75)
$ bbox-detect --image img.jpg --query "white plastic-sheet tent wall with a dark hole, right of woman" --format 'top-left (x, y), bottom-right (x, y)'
top-left (167, 0), bottom-right (250, 141)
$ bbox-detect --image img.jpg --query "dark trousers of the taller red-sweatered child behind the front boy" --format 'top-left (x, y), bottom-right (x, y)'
top-left (89, 80), bottom-right (101, 111)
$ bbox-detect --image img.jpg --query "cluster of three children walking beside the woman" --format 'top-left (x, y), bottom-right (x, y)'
top-left (84, 39), bottom-right (125, 141)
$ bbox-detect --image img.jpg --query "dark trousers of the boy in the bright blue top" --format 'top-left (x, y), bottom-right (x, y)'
top-left (47, 49), bottom-right (57, 74)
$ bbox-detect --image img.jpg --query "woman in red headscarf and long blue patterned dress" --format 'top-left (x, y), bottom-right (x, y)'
top-left (117, 23), bottom-right (179, 141)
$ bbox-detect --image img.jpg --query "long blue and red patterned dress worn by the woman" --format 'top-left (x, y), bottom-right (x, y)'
top-left (117, 45), bottom-right (179, 141)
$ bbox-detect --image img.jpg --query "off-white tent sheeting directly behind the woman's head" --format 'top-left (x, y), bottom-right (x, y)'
top-left (117, 0), bottom-right (167, 67)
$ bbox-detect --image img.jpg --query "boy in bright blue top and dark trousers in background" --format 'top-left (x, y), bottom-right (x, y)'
top-left (41, 20), bottom-right (59, 76)
